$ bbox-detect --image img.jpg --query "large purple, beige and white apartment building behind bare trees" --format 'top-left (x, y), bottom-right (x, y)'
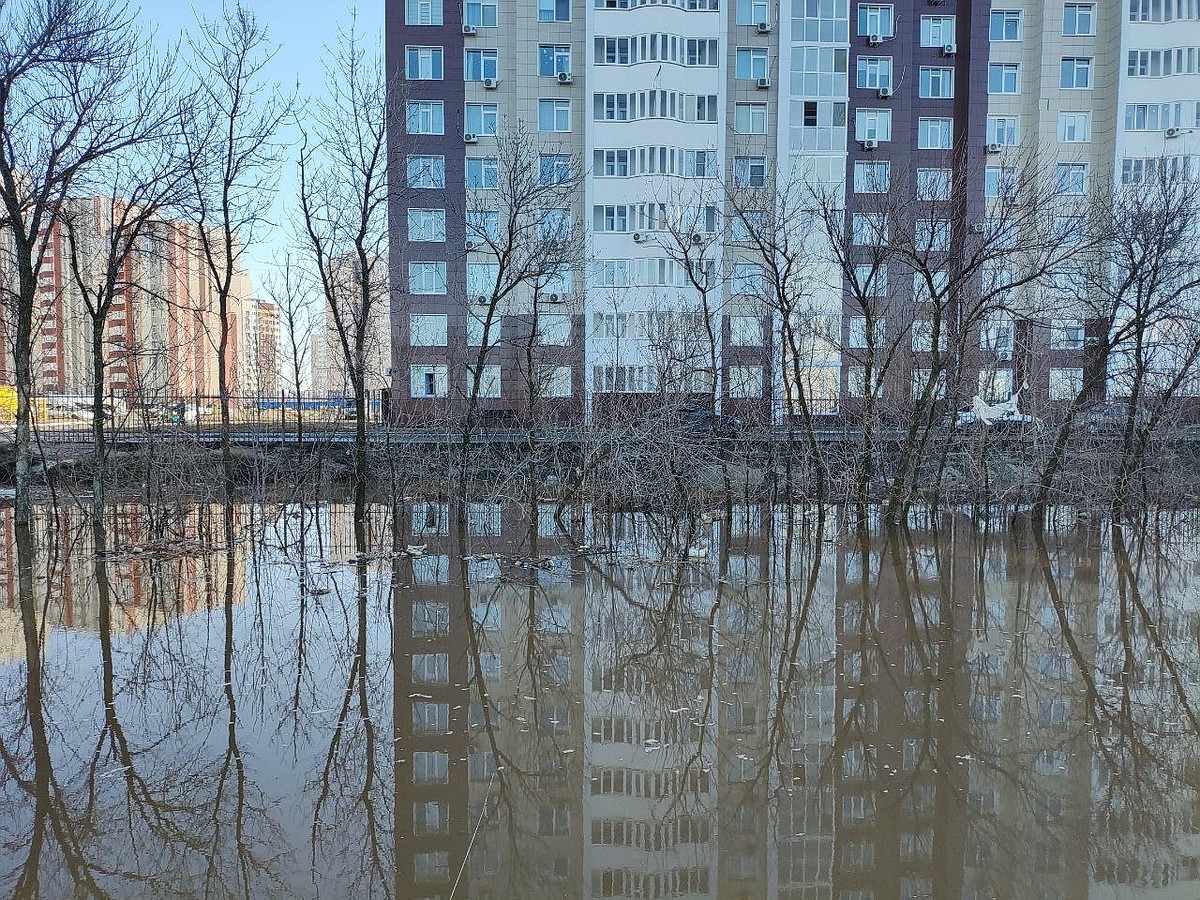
top-left (386, 0), bottom-right (1200, 420)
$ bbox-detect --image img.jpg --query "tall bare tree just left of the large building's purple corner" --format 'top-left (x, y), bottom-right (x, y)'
top-left (300, 10), bottom-right (389, 484)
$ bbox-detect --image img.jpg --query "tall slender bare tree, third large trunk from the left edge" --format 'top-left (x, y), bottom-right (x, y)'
top-left (179, 0), bottom-right (292, 496)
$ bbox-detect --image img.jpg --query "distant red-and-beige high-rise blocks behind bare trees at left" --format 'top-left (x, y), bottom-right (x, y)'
top-left (7, 197), bottom-right (278, 402)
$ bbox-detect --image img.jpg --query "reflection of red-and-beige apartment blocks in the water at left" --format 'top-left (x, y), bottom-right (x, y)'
top-left (0, 505), bottom-right (250, 672)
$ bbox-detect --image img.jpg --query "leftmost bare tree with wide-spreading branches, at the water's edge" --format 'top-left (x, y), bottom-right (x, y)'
top-left (0, 0), bottom-right (174, 524)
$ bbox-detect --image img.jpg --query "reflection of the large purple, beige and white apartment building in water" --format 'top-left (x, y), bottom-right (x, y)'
top-left (396, 502), bottom-right (1198, 900)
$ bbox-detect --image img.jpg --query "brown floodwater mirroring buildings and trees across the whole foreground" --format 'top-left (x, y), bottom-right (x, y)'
top-left (0, 500), bottom-right (1200, 900)
